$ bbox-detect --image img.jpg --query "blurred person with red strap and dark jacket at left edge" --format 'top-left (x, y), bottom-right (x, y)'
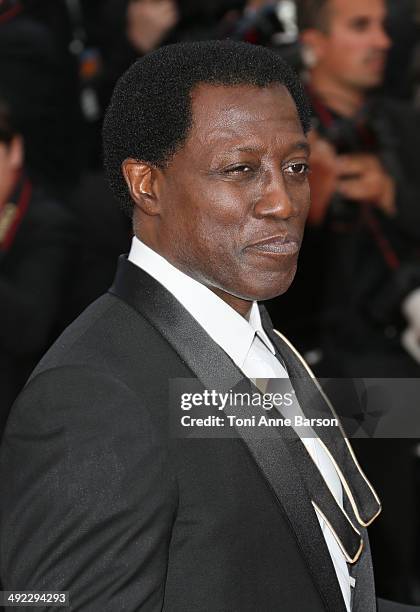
top-left (0, 98), bottom-right (75, 437)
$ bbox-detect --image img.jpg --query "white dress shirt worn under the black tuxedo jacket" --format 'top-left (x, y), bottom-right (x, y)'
top-left (128, 237), bottom-right (354, 612)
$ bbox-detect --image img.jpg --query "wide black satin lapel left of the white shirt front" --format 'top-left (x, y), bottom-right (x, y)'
top-left (110, 256), bottom-right (346, 612)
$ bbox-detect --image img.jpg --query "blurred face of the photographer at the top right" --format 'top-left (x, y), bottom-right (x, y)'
top-left (316, 0), bottom-right (391, 90)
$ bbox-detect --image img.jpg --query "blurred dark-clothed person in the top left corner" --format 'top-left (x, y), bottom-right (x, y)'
top-left (0, 0), bottom-right (83, 199)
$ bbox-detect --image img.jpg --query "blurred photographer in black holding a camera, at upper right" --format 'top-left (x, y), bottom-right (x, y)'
top-left (272, 0), bottom-right (420, 377)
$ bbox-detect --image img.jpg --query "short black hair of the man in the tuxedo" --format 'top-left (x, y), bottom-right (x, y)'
top-left (103, 40), bottom-right (310, 216)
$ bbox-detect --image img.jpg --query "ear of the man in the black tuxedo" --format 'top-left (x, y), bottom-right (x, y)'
top-left (121, 158), bottom-right (160, 216)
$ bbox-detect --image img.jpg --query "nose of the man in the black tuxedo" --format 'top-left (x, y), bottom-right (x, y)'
top-left (254, 171), bottom-right (299, 219)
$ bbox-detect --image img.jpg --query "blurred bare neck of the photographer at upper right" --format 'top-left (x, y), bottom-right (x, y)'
top-left (310, 68), bottom-right (366, 118)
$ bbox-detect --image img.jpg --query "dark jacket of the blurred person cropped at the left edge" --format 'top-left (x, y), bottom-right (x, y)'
top-left (0, 179), bottom-right (77, 435)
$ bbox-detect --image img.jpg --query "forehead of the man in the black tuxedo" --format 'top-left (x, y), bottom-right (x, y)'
top-left (186, 84), bottom-right (303, 153)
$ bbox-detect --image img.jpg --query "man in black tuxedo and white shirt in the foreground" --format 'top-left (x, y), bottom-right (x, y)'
top-left (0, 41), bottom-right (414, 612)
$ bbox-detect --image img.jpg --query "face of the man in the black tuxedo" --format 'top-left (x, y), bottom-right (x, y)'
top-left (147, 85), bottom-right (309, 307)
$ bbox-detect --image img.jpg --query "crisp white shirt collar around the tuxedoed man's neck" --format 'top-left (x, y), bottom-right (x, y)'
top-left (128, 236), bottom-right (275, 368)
